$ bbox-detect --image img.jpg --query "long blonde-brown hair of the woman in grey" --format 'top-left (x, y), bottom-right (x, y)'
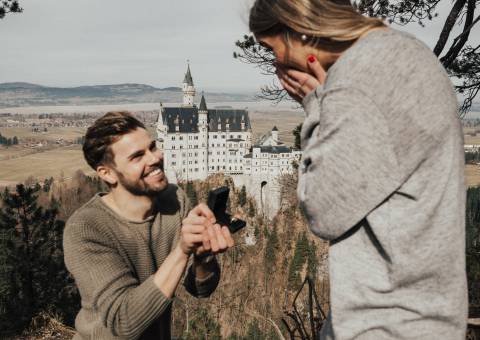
top-left (249, 0), bottom-right (385, 47)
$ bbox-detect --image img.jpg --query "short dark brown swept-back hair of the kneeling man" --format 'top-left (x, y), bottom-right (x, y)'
top-left (83, 111), bottom-right (145, 170)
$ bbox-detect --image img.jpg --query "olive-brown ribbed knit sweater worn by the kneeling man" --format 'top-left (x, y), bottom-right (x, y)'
top-left (63, 185), bottom-right (220, 340)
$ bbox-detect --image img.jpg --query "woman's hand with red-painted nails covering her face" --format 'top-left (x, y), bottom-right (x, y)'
top-left (277, 55), bottom-right (327, 104)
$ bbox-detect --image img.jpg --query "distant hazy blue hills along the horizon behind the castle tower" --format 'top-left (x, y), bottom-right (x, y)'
top-left (0, 82), bottom-right (255, 108)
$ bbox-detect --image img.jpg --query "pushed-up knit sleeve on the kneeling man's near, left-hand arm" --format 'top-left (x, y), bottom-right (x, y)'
top-left (64, 222), bottom-right (171, 339)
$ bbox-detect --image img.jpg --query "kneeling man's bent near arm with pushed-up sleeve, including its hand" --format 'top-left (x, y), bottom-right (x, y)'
top-left (64, 211), bottom-right (216, 339)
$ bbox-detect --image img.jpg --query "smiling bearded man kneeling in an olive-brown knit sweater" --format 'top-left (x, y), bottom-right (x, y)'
top-left (64, 112), bottom-right (233, 340)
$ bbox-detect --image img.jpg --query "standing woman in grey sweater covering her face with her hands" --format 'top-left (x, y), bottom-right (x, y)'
top-left (250, 0), bottom-right (467, 340)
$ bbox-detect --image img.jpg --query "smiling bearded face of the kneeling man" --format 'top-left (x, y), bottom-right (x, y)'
top-left (111, 128), bottom-right (168, 196)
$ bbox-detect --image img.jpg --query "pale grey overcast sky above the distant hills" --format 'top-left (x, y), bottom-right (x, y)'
top-left (0, 0), bottom-right (478, 92)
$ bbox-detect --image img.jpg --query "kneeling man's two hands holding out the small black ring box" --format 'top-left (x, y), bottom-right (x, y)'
top-left (179, 203), bottom-right (234, 255)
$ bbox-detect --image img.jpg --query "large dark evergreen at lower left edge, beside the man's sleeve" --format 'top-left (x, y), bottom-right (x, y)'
top-left (0, 184), bottom-right (79, 331)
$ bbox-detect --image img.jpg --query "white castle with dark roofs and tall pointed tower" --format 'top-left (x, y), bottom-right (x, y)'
top-left (156, 65), bottom-right (301, 216)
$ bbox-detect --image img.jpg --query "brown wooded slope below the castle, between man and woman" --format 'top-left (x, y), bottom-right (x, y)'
top-left (174, 175), bottom-right (329, 339)
